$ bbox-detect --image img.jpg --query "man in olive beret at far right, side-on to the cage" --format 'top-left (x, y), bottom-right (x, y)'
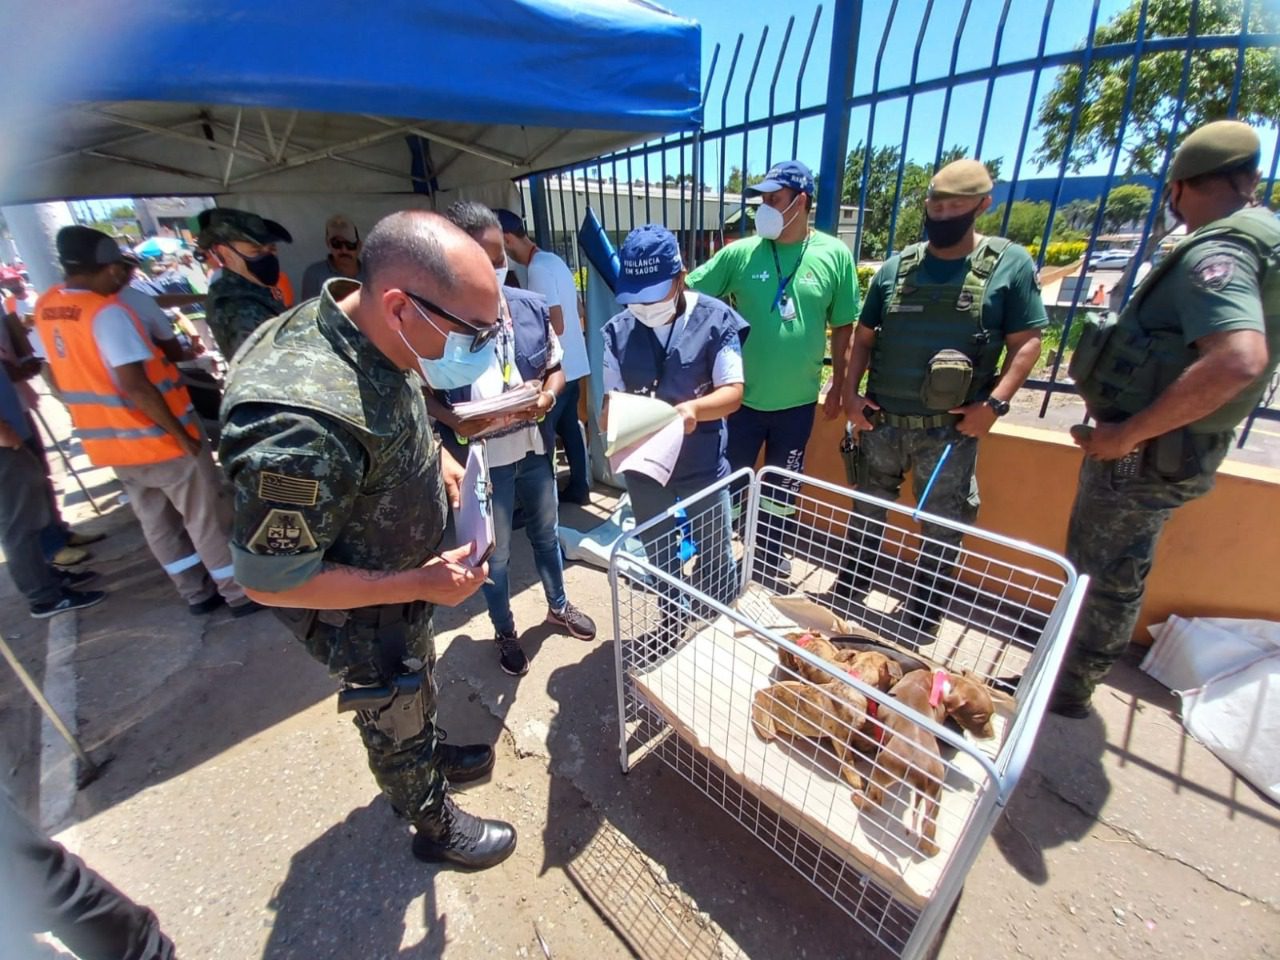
top-left (1050, 120), bottom-right (1280, 718)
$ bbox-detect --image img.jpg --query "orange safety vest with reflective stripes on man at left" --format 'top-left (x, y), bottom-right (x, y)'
top-left (36, 284), bottom-right (200, 467)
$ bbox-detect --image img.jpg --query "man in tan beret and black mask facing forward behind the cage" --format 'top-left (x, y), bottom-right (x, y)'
top-left (836, 160), bottom-right (1048, 630)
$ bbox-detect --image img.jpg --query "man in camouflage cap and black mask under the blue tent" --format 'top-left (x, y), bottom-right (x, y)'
top-left (197, 207), bottom-right (293, 361)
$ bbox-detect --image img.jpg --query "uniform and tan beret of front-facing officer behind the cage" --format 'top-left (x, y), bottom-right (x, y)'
top-left (836, 160), bottom-right (1048, 630)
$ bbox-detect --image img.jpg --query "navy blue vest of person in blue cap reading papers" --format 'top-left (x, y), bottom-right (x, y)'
top-left (603, 293), bottom-right (750, 484)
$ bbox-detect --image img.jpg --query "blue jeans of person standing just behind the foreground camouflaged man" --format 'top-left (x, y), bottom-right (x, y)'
top-left (481, 453), bottom-right (568, 634)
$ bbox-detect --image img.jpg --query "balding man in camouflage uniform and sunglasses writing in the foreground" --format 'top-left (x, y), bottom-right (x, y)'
top-left (221, 211), bottom-right (516, 868)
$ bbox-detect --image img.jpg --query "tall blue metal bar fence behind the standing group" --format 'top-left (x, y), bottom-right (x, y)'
top-left (529, 0), bottom-right (1280, 442)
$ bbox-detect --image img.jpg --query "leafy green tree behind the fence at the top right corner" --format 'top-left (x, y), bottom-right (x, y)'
top-left (1036, 0), bottom-right (1280, 173)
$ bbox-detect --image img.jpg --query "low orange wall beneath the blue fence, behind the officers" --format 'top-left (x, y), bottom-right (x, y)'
top-left (805, 412), bottom-right (1280, 644)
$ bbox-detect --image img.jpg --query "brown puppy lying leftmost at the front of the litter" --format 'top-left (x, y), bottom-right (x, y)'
top-left (751, 680), bottom-right (867, 791)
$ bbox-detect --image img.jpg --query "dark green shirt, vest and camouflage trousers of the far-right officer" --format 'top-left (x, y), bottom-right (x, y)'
top-left (1055, 216), bottom-right (1280, 716)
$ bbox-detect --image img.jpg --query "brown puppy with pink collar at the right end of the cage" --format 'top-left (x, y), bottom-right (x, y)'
top-left (854, 669), bottom-right (995, 856)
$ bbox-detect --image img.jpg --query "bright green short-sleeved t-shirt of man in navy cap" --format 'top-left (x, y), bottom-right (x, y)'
top-left (689, 230), bottom-right (858, 411)
